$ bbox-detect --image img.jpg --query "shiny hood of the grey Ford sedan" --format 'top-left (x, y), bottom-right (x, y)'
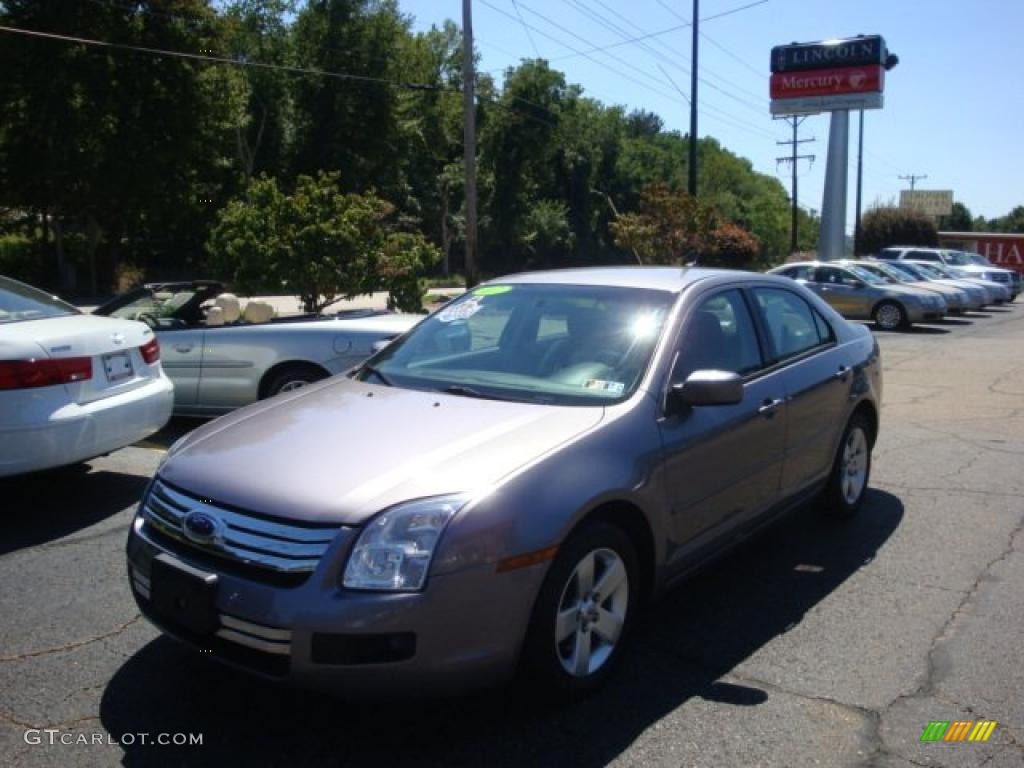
top-left (159, 379), bottom-right (604, 524)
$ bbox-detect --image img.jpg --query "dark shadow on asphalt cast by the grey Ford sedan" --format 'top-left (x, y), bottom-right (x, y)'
top-left (99, 490), bottom-right (903, 768)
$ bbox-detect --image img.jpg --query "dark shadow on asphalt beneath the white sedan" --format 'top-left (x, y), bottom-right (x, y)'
top-left (0, 464), bottom-right (150, 555)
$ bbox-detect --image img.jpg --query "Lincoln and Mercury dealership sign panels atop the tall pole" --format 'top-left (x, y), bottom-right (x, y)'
top-left (770, 35), bottom-right (896, 115)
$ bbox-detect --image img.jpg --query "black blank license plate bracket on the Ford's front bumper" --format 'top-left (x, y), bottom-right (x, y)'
top-left (150, 554), bottom-right (220, 635)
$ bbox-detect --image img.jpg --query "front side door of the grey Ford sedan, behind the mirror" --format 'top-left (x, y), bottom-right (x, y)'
top-left (658, 289), bottom-right (786, 555)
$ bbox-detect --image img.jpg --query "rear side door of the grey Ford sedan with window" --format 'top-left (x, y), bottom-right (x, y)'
top-left (752, 287), bottom-right (853, 497)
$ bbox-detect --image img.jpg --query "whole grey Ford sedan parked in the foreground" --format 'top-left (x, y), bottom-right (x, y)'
top-left (127, 267), bottom-right (882, 696)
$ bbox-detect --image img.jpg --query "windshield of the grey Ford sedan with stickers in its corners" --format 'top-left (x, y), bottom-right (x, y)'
top-left (356, 284), bottom-right (674, 406)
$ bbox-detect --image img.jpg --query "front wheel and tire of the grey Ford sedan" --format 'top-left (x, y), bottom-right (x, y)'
top-left (521, 522), bottom-right (640, 699)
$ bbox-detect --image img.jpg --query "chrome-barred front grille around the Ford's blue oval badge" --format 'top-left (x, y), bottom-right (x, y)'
top-left (140, 479), bottom-right (342, 579)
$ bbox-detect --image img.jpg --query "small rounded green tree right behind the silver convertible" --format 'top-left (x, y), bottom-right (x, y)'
top-left (208, 173), bottom-right (393, 312)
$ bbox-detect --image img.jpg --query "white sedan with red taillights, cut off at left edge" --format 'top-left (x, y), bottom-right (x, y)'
top-left (0, 276), bottom-right (174, 477)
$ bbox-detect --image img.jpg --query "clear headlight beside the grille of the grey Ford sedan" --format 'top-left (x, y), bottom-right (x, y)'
top-left (342, 494), bottom-right (469, 592)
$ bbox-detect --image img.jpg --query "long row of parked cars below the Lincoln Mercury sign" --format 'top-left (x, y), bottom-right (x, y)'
top-left (769, 249), bottom-right (1018, 331)
